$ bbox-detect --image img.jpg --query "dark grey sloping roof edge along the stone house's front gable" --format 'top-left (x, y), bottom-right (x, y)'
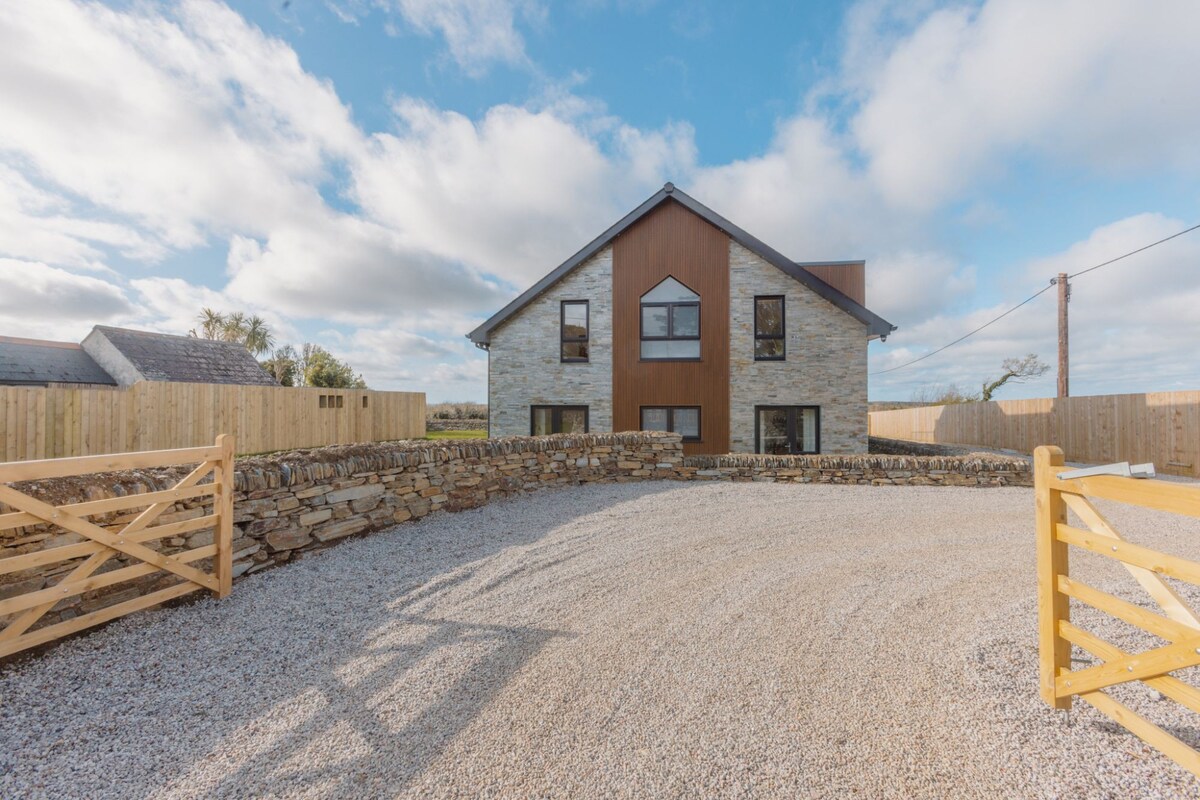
top-left (467, 184), bottom-right (896, 345)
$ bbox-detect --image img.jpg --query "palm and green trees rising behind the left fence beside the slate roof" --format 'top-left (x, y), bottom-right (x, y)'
top-left (187, 308), bottom-right (367, 389)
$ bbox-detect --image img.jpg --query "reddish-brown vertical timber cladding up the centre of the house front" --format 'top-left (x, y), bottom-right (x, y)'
top-left (612, 200), bottom-right (730, 455)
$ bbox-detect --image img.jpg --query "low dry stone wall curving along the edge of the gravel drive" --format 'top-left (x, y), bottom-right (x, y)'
top-left (0, 433), bottom-right (1032, 647)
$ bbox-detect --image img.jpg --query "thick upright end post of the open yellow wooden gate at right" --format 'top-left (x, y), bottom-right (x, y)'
top-left (1033, 446), bottom-right (1072, 709)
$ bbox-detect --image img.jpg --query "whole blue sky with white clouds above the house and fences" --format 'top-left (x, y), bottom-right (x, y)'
top-left (0, 0), bottom-right (1200, 401)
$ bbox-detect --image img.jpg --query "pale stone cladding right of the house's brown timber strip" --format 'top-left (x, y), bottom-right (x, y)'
top-left (730, 240), bottom-right (868, 453)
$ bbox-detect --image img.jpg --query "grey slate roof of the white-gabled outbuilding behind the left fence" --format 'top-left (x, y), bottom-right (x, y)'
top-left (94, 325), bottom-right (278, 386)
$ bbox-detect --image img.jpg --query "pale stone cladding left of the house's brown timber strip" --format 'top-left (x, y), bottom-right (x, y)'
top-left (488, 246), bottom-right (614, 437)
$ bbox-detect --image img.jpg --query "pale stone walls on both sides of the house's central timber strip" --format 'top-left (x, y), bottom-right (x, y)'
top-left (488, 219), bottom-right (869, 455)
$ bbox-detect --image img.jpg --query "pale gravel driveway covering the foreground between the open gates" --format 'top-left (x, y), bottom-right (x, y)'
top-left (0, 483), bottom-right (1200, 799)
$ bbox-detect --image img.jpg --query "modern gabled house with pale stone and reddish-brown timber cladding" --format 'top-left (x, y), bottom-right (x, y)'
top-left (469, 184), bottom-right (895, 453)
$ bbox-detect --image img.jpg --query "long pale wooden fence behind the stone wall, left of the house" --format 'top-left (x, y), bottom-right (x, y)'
top-left (0, 381), bottom-right (425, 462)
